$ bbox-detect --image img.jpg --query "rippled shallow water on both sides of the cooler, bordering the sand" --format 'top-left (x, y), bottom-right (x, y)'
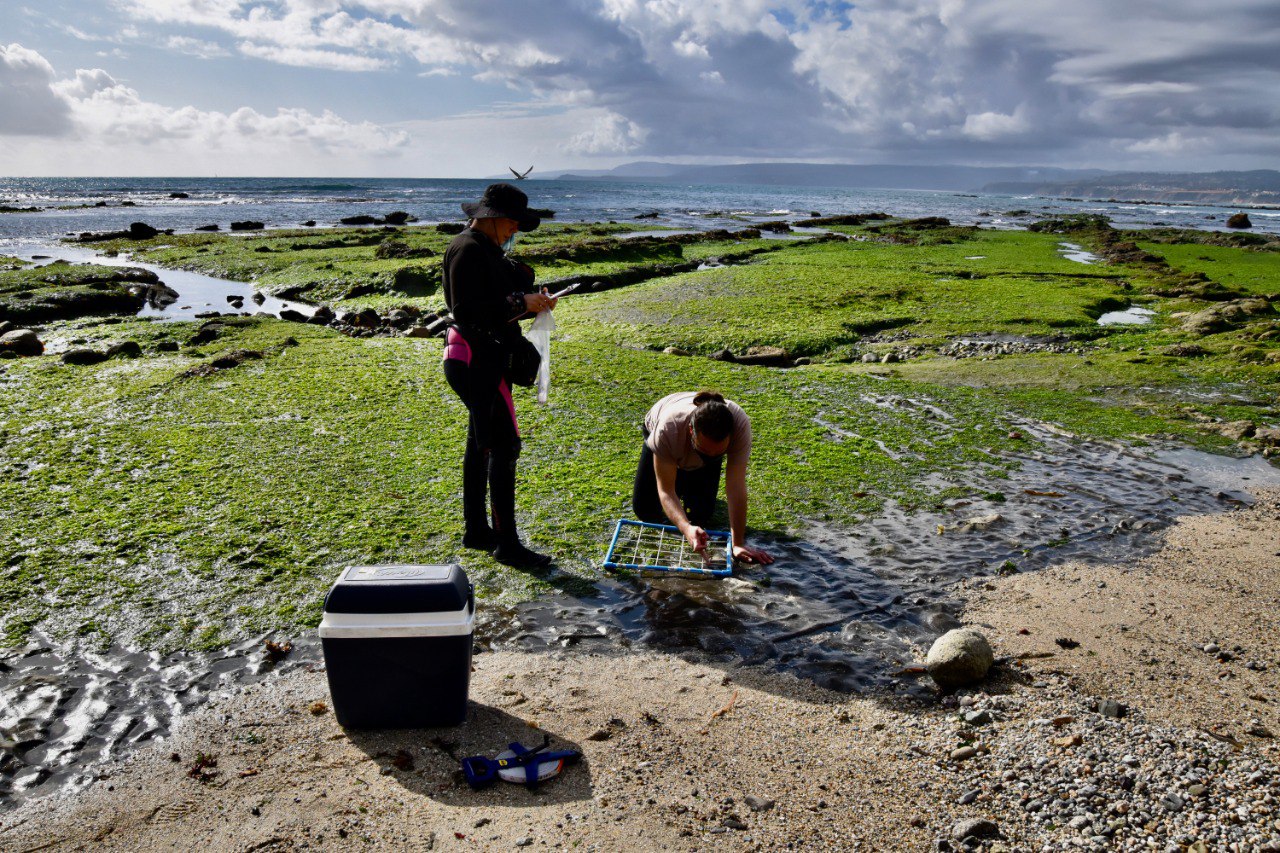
top-left (0, 424), bottom-right (1280, 811)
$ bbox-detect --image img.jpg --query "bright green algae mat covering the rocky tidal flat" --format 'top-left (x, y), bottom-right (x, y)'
top-left (0, 216), bottom-right (1280, 648)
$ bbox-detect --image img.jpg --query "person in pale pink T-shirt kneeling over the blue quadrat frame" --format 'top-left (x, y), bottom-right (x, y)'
top-left (631, 391), bottom-right (773, 565)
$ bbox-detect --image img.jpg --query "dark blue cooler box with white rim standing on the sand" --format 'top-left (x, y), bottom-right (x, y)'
top-left (320, 565), bottom-right (475, 729)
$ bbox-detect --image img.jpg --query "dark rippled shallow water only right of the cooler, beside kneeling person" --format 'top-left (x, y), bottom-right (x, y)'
top-left (486, 425), bottom-right (1280, 694)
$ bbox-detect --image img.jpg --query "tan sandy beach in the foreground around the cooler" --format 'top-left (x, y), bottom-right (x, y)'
top-left (0, 491), bottom-right (1280, 850)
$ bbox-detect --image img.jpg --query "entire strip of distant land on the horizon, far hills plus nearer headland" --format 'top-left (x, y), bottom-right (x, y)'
top-left (536, 161), bottom-right (1280, 205)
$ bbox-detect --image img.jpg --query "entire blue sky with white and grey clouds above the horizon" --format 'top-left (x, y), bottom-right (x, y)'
top-left (0, 0), bottom-right (1280, 178)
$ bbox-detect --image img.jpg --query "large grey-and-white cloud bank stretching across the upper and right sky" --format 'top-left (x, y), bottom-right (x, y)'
top-left (87, 0), bottom-right (1280, 165)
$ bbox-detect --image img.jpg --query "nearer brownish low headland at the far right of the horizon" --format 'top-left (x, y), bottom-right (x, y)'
top-left (982, 169), bottom-right (1280, 205)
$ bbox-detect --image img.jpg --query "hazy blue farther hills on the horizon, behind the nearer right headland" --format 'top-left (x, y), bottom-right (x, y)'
top-left (545, 163), bottom-right (1106, 192)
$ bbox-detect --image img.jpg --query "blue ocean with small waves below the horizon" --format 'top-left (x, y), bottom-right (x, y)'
top-left (0, 178), bottom-right (1280, 247)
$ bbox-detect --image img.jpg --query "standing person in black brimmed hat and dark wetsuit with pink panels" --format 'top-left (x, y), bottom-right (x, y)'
top-left (443, 183), bottom-right (556, 567)
